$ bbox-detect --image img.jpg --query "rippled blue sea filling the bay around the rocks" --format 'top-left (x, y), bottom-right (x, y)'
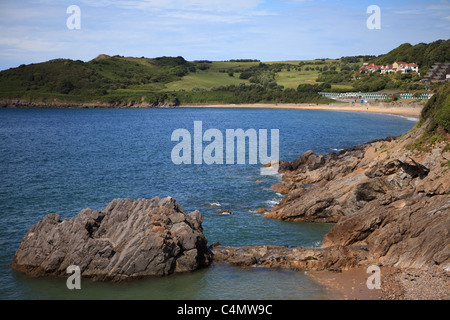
top-left (0, 108), bottom-right (415, 300)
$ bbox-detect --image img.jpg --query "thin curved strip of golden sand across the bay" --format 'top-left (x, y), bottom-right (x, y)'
top-left (179, 103), bottom-right (425, 119)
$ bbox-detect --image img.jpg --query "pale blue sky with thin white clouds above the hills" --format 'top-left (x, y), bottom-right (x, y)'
top-left (0, 0), bottom-right (450, 70)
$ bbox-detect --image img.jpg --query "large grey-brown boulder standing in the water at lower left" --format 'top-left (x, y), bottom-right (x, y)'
top-left (11, 197), bottom-right (210, 281)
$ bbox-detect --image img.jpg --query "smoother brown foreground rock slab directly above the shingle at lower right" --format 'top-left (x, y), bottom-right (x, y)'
top-left (323, 194), bottom-right (450, 269)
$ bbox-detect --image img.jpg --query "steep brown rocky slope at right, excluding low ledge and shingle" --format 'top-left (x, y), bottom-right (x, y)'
top-left (265, 124), bottom-right (450, 268)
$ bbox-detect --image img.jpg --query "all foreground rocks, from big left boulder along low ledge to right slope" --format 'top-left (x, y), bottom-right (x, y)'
top-left (11, 99), bottom-right (450, 299)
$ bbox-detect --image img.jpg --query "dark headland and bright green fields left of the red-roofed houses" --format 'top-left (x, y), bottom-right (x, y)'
top-left (0, 55), bottom-right (337, 105)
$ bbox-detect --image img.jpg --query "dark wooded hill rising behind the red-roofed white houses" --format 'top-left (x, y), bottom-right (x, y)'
top-left (372, 39), bottom-right (450, 74)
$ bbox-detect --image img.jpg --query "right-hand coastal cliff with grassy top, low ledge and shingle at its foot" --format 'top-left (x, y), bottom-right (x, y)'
top-left (212, 84), bottom-right (450, 300)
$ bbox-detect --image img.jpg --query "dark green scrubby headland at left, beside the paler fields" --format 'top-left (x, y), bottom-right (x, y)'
top-left (0, 55), bottom-right (193, 97)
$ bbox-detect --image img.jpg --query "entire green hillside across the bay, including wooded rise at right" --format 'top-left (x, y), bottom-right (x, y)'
top-left (0, 40), bottom-right (450, 105)
